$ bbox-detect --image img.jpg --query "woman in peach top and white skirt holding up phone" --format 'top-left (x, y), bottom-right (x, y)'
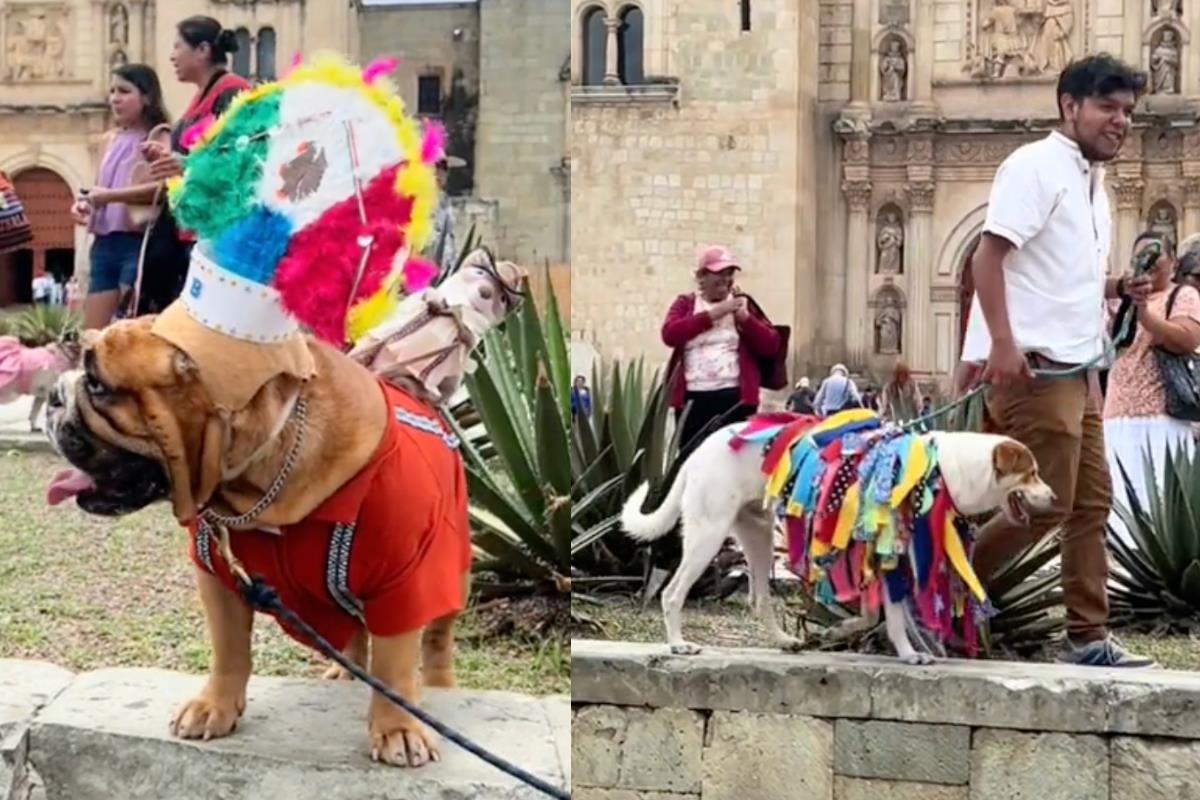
top-left (1104, 231), bottom-right (1200, 544)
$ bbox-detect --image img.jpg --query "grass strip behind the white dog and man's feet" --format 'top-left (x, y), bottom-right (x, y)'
top-left (574, 593), bottom-right (1200, 670)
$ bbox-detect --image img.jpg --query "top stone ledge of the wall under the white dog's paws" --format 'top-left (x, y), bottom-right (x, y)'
top-left (571, 639), bottom-right (1200, 739)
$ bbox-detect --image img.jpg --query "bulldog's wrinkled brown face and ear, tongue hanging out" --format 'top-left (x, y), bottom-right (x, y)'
top-left (47, 318), bottom-right (229, 521)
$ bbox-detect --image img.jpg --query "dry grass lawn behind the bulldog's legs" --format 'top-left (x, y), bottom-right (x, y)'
top-left (0, 452), bottom-right (570, 694)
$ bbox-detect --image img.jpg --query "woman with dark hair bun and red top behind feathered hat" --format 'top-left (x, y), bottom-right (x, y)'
top-left (137, 16), bottom-right (250, 313)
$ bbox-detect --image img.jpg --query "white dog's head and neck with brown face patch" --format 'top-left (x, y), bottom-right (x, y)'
top-left (929, 433), bottom-right (1055, 525)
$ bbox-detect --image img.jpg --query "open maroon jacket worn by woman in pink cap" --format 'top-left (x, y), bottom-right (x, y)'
top-left (662, 293), bottom-right (780, 408)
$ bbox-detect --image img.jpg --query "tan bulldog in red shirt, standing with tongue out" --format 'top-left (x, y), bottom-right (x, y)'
top-left (47, 317), bottom-right (470, 766)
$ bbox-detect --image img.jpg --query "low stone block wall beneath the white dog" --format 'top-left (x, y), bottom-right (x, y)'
top-left (571, 640), bottom-right (1200, 800)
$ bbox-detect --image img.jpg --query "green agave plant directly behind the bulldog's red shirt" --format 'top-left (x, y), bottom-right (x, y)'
top-left (449, 262), bottom-right (571, 593)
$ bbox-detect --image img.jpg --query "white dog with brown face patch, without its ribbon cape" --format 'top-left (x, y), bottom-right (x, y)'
top-left (622, 422), bottom-right (1054, 663)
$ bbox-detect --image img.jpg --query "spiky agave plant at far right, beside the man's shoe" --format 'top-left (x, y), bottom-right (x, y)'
top-left (1108, 449), bottom-right (1200, 633)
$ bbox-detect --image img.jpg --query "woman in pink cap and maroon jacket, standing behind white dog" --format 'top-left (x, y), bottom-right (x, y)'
top-left (662, 247), bottom-right (781, 453)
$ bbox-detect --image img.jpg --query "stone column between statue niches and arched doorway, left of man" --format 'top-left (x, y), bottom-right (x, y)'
top-left (904, 181), bottom-right (936, 373)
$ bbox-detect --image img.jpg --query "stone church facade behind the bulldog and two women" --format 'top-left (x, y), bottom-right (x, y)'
top-left (0, 0), bottom-right (570, 307)
